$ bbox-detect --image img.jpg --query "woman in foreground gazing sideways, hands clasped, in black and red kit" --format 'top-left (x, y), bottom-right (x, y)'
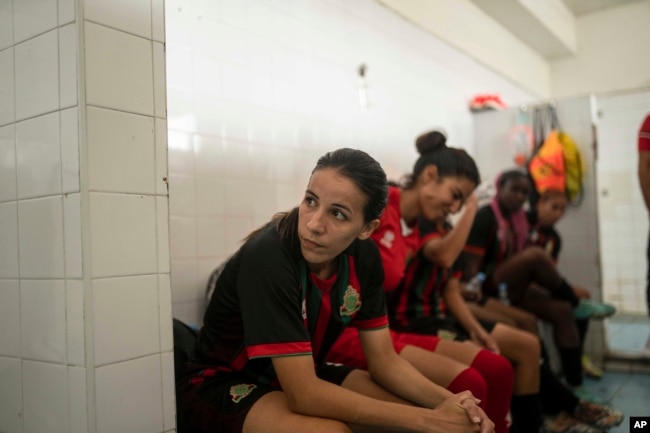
top-left (177, 149), bottom-right (494, 433)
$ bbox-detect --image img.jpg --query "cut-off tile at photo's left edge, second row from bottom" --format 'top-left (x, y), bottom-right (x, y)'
top-left (0, 279), bottom-right (20, 356)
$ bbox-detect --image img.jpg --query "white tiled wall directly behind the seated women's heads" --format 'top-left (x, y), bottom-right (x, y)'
top-left (165, 0), bottom-right (535, 324)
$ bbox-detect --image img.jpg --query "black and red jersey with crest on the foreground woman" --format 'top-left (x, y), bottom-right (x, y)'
top-left (193, 224), bottom-right (388, 385)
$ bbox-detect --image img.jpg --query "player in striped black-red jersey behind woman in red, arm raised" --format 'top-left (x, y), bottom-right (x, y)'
top-left (389, 208), bottom-right (623, 433)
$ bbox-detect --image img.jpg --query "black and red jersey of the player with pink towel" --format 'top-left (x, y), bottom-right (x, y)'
top-left (463, 204), bottom-right (514, 275)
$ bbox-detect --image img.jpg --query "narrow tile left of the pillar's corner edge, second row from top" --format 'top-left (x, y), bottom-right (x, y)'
top-left (59, 23), bottom-right (77, 108)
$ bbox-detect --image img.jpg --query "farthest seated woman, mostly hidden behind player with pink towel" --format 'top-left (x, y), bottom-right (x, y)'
top-left (526, 189), bottom-right (616, 379)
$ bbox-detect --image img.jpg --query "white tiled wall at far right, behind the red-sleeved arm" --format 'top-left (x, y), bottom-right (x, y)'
top-left (597, 92), bottom-right (650, 314)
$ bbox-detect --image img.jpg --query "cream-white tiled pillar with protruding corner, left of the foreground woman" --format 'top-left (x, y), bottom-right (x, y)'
top-left (0, 0), bottom-right (175, 433)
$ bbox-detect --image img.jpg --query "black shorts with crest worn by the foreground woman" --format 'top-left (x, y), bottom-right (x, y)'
top-left (176, 364), bottom-right (353, 433)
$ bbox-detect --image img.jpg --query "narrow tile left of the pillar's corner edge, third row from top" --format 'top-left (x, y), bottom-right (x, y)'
top-left (60, 107), bottom-right (79, 193)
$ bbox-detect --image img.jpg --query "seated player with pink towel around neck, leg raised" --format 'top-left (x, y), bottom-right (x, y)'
top-left (463, 170), bottom-right (612, 398)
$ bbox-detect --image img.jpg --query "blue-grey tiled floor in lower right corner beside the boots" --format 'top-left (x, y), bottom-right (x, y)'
top-left (584, 316), bottom-right (650, 433)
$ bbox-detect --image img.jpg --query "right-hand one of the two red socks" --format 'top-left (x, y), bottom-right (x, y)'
top-left (471, 349), bottom-right (515, 433)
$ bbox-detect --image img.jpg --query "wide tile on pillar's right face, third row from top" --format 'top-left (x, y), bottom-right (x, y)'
top-left (87, 107), bottom-right (155, 194)
